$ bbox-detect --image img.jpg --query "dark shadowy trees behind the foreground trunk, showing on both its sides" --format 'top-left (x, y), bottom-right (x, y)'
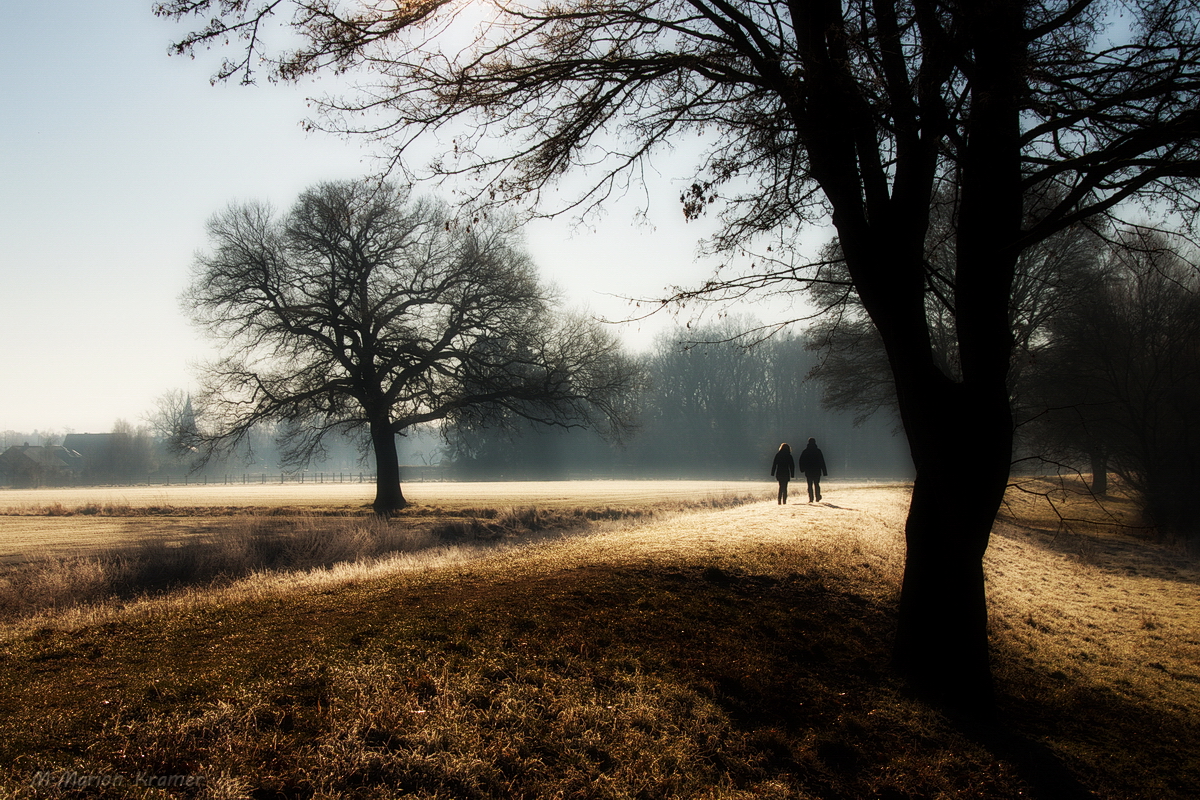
top-left (808, 212), bottom-right (1200, 548)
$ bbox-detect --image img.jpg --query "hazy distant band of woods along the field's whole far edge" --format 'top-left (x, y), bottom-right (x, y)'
top-left (2, 324), bottom-right (912, 483)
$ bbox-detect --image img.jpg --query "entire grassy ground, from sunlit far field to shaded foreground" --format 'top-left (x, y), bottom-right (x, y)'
top-left (0, 481), bottom-right (1200, 800)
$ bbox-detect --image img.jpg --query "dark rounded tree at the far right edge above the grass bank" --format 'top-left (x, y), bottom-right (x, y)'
top-left (1037, 229), bottom-right (1200, 547)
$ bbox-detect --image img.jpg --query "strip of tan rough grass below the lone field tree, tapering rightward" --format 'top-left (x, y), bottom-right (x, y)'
top-left (0, 486), bottom-right (757, 626)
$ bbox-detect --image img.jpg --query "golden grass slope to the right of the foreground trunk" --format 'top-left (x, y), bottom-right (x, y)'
top-left (986, 481), bottom-right (1200, 798)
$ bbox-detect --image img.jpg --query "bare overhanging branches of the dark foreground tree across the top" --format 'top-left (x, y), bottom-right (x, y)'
top-left (155, 0), bottom-right (1198, 227)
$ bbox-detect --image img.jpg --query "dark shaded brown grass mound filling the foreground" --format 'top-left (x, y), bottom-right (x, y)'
top-left (0, 496), bottom-right (1185, 800)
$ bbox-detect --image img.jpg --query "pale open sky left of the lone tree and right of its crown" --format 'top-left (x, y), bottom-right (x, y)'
top-left (0, 0), bottom-right (811, 434)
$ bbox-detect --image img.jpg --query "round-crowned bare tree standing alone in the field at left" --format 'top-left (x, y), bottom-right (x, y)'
top-left (184, 181), bottom-right (635, 515)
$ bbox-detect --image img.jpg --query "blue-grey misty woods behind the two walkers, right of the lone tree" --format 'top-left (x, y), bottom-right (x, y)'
top-left (445, 319), bottom-right (912, 481)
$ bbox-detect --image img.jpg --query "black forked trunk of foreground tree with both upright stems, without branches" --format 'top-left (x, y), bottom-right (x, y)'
top-left (793, 0), bottom-right (1026, 715)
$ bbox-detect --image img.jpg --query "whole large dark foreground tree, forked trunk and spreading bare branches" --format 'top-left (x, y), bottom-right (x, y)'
top-left (164, 0), bottom-right (1200, 710)
